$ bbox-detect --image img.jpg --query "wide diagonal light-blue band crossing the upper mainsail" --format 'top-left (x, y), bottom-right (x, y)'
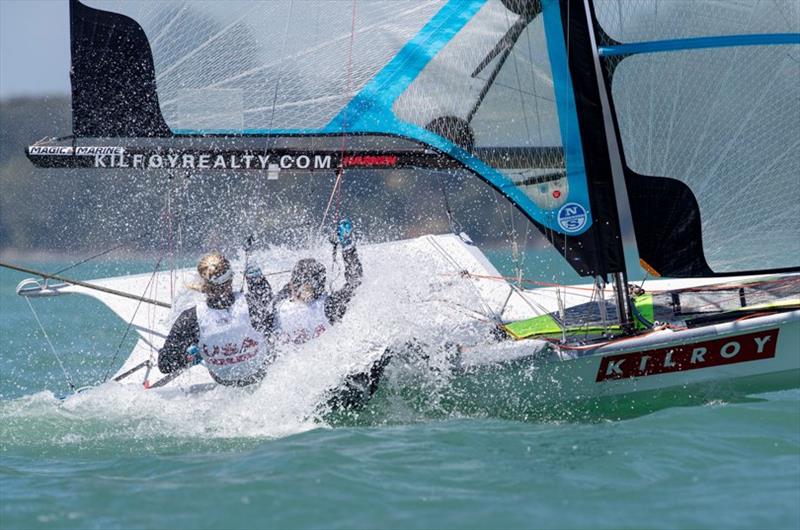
top-left (324, 0), bottom-right (486, 132)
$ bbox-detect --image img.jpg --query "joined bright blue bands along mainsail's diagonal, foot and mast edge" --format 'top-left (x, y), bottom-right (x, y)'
top-left (174, 0), bottom-right (592, 235)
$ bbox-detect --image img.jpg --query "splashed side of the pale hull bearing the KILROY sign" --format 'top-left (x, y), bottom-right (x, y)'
top-left (446, 311), bottom-right (800, 417)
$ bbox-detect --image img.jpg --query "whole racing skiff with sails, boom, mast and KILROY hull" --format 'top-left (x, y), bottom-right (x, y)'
top-left (7, 0), bottom-right (800, 416)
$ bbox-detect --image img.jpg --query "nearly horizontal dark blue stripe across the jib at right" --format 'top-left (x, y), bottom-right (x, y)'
top-left (598, 33), bottom-right (800, 57)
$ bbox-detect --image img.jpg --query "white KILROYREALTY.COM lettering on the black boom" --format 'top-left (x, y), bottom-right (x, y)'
top-left (94, 153), bottom-right (332, 170)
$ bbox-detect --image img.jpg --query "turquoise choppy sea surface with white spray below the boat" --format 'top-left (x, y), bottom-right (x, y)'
top-left (0, 261), bottom-right (800, 529)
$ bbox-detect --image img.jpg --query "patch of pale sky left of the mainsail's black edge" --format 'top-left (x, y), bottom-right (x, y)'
top-left (0, 0), bottom-right (70, 99)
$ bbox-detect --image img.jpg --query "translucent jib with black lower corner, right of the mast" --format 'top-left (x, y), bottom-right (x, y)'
top-left (588, 0), bottom-right (800, 277)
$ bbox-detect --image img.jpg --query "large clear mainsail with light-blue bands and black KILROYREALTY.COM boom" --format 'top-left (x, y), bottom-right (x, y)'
top-left (29, 0), bottom-right (624, 276)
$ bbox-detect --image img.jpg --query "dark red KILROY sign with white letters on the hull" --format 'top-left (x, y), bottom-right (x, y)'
top-left (596, 329), bottom-right (778, 382)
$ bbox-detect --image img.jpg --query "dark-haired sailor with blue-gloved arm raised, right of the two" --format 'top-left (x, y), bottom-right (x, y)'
top-left (275, 219), bottom-right (363, 344)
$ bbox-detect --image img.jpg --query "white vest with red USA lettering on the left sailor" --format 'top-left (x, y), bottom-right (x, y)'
top-left (197, 293), bottom-right (270, 382)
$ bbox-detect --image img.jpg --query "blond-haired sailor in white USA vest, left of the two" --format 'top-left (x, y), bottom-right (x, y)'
top-left (158, 252), bottom-right (273, 386)
